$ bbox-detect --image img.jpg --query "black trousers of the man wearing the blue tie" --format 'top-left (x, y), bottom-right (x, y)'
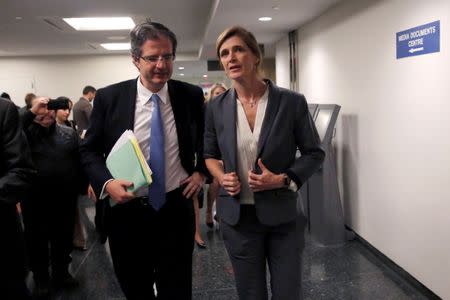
top-left (109, 188), bottom-right (195, 300)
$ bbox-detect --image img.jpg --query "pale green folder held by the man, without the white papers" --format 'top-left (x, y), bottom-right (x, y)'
top-left (106, 140), bottom-right (152, 206)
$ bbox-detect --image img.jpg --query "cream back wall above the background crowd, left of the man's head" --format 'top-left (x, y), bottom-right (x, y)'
top-left (0, 55), bottom-right (138, 106)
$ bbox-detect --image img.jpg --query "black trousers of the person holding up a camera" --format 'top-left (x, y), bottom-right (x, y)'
top-left (22, 190), bottom-right (77, 282)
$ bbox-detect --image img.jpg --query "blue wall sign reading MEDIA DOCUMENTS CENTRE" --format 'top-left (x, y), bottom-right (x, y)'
top-left (397, 21), bottom-right (441, 59)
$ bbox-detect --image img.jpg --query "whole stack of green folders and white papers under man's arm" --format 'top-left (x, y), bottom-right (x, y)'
top-left (106, 130), bottom-right (152, 206)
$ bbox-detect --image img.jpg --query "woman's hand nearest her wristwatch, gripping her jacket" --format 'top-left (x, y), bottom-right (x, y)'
top-left (248, 158), bottom-right (284, 192)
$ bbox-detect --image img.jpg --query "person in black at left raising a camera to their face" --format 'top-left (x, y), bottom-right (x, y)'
top-left (22, 97), bottom-right (87, 297)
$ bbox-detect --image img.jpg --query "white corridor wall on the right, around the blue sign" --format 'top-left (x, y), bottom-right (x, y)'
top-left (290, 0), bottom-right (450, 299)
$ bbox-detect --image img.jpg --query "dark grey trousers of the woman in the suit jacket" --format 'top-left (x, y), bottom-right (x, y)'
top-left (221, 205), bottom-right (305, 300)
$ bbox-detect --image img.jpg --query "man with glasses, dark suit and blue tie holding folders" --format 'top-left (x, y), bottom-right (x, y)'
top-left (81, 21), bottom-right (206, 300)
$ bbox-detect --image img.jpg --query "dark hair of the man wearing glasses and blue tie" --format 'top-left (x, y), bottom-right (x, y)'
top-left (130, 19), bottom-right (177, 59)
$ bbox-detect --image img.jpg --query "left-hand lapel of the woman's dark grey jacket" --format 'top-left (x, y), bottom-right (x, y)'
top-left (222, 88), bottom-right (237, 172)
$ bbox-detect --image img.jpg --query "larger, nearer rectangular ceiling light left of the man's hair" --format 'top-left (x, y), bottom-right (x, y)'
top-left (63, 17), bottom-right (135, 31)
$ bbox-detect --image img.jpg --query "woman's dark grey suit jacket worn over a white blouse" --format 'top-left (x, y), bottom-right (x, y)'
top-left (204, 80), bottom-right (325, 225)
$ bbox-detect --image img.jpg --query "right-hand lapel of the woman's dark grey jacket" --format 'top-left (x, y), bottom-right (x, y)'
top-left (257, 80), bottom-right (280, 158)
